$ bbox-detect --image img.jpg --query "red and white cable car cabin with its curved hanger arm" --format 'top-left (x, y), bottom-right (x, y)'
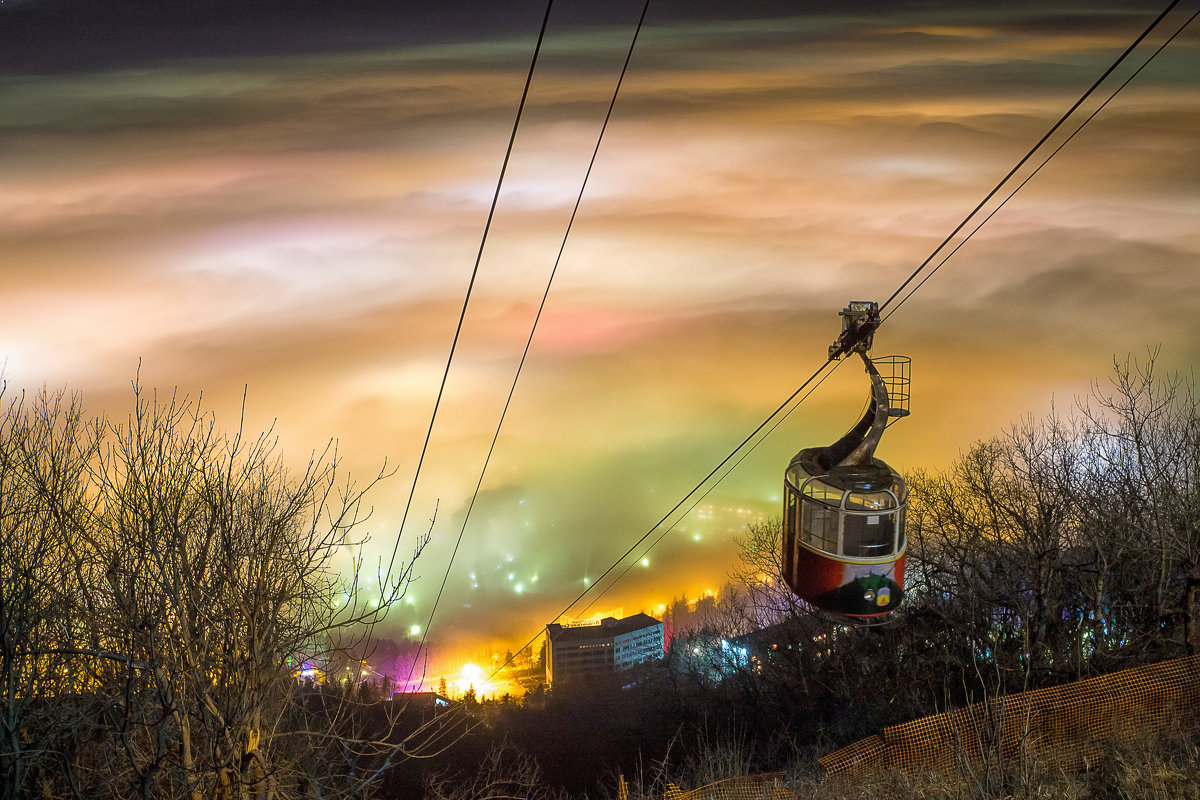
top-left (781, 300), bottom-right (911, 619)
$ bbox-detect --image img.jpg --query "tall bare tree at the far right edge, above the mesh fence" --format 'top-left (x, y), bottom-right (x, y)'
top-left (1076, 350), bottom-right (1200, 654)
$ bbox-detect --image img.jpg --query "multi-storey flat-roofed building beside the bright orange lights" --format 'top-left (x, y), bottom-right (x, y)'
top-left (546, 614), bottom-right (662, 686)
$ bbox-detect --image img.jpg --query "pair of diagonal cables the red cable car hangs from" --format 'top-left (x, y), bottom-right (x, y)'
top-left (492, 0), bottom-right (1200, 676)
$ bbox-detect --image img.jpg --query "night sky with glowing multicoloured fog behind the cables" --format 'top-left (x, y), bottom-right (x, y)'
top-left (0, 0), bottom-right (1200, 671)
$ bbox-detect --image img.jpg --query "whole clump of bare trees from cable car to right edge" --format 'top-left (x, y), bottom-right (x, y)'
top-left (910, 353), bottom-right (1200, 688)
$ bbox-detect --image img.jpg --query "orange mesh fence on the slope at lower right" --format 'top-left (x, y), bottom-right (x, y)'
top-left (820, 655), bottom-right (1200, 776)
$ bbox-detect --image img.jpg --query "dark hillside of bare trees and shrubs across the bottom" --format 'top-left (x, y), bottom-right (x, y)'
top-left (0, 357), bottom-right (1200, 800)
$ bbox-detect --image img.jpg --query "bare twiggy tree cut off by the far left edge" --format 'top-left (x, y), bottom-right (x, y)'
top-left (0, 386), bottom-right (96, 798)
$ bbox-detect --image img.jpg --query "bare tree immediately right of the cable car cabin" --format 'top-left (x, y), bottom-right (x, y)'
top-left (908, 417), bottom-right (1091, 681)
